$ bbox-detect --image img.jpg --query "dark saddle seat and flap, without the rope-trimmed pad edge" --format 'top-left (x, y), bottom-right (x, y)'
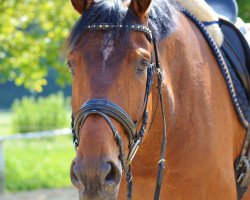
top-left (206, 0), bottom-right (250, 105)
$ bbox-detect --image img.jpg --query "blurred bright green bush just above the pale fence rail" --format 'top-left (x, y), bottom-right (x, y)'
top-left (11, 93), bottom-right (70, 133)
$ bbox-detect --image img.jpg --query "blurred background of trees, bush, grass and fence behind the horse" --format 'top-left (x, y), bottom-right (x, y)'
top-left (0, 0), bottom-right (250, 200)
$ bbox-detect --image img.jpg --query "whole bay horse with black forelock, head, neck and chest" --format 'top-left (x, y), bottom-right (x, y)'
top-left (65, 0), bottom-right (250, 200)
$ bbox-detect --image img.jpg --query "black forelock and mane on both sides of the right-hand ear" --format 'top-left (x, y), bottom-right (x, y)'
top-left (65, 0), bottom-right (177, 54)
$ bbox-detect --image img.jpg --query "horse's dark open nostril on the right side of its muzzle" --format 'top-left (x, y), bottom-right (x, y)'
top-left (104, 162), bottom-right (121, 185)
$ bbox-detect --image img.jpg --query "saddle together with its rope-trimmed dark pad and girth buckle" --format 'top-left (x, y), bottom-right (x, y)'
top-left (184, 0), bottom-right (250, 200)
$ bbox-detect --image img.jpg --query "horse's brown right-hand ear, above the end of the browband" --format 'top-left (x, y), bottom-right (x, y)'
top-left (130, 0), bottom-right (152, 19)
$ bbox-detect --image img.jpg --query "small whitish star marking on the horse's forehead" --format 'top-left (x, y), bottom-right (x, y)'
top-left (101, 33), bottom-right (114, 68)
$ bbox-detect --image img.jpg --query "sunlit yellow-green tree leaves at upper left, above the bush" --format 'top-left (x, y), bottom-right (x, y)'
top-left (0, 0), bottom-right (78, 92)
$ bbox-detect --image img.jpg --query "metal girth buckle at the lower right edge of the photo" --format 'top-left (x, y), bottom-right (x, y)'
top-left (237, 157), bottom-right (250, 187)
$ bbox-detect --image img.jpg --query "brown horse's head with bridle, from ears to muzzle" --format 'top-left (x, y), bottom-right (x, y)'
top-left (67, 0), bottom-right (153, 199)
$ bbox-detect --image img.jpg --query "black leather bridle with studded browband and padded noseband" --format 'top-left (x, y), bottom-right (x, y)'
top-left (71, 24), bottom-right (166, 200)
